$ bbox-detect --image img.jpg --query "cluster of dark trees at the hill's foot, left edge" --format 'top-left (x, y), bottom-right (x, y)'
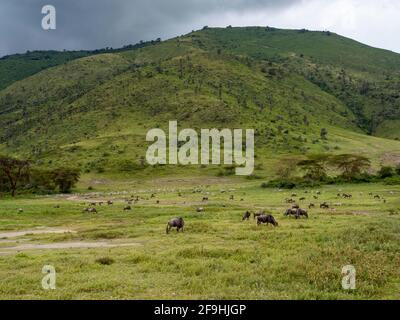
top-left (0, 155), bottom-right (80, 197)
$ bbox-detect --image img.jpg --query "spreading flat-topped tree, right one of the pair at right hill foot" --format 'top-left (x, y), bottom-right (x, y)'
top-left (331, 154), bottom-right (371, 180)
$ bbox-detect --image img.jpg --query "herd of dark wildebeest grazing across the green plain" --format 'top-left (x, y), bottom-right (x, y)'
top-left (76, 191), bottom-right (386, 234)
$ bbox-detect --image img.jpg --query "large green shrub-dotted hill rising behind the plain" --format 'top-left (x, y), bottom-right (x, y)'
top-left (0, 27), bottom-right (400, 178)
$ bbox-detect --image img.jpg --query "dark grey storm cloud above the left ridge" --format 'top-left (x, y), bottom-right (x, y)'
top-left (0, 0), bottom-right (301, 56)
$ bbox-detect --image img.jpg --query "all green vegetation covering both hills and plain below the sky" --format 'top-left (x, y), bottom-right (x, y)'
top-left (0, 27), bottom-right (400, 299)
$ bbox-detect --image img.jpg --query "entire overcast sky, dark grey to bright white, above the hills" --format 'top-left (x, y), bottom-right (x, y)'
top-left (0, 0), bottom-right (400, 56)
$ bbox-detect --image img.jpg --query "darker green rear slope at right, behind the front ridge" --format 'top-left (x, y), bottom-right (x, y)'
top-left (188, 27), bottom-right (400, 138)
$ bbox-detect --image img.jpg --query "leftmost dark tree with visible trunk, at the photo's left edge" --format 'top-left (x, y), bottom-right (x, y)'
top-left (0, 156), bottom-right (30, 197)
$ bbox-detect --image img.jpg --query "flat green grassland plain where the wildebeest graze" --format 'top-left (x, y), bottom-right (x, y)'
top-left (0, 177), bottom-right (400, 299)
